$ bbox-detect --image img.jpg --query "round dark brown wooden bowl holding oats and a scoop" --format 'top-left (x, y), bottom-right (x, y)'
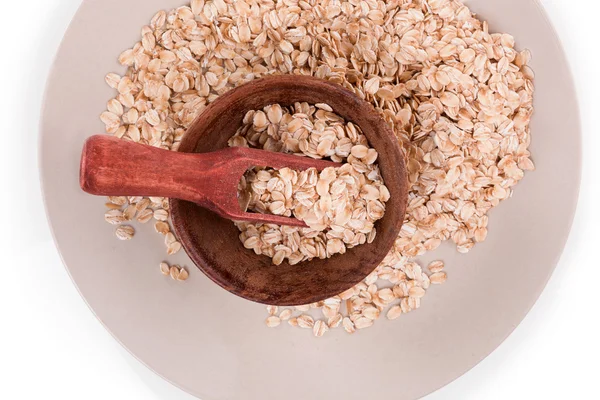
top-left (170, 75), bottom-right (408, 305)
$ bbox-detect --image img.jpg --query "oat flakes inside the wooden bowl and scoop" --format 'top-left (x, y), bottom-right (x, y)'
top-left (229, 102), bottom-right (390, 265)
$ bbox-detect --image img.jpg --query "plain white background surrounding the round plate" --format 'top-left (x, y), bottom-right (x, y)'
top-left (0, 0), bottom-right (600, 400)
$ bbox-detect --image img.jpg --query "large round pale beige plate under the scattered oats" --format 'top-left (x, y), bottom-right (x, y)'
top-left (40, 0), bottom-right (581, 400)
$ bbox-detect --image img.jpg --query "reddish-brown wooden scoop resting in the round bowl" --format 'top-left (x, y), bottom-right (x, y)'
top-left (79, 135), bottom-right (340, 227)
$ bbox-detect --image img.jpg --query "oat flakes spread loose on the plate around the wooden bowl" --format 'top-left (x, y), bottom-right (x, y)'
top-left (101, 0), bottom-right (534, 336)
